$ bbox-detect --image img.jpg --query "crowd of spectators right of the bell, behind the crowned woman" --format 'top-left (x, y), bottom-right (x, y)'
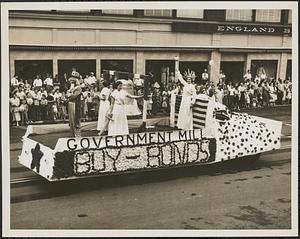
top-left (146, 70), bottom-right (292, 114)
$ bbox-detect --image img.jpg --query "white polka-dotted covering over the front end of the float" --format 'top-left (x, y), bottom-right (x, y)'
top-left (216, 113), bottom-right (281, 161)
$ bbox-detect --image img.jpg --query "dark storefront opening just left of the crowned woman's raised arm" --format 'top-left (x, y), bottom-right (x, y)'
top-left (146, 60), bottom-right (175, 89)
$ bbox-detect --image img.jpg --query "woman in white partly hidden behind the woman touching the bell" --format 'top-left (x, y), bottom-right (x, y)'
top-left (97, 81), bottom-right (110, 132)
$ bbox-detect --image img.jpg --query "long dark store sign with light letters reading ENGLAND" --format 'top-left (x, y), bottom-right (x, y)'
top-left (172, 22), bottom-right (292, 35)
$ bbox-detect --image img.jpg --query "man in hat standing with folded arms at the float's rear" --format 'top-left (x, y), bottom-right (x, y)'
top-left (66, 68), bottom-right (82, 137)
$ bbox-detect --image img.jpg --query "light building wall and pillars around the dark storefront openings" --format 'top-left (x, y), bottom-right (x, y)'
top-left (9, 14), bottom-right (292, 84)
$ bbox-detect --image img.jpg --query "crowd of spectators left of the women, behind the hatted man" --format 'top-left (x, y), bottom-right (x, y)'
top-left (10, 72), bottom-right (100, 126)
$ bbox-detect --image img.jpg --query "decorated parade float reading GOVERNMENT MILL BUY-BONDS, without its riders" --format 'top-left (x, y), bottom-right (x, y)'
top-left (19, 65), bottom-right (282, 181)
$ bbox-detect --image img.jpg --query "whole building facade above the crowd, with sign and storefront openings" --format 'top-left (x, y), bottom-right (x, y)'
top-left (9, 9), bottom-right (292, 85)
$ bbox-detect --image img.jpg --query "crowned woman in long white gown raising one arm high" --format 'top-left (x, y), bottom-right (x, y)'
top-left (176, 70), bottom-right (196, 130)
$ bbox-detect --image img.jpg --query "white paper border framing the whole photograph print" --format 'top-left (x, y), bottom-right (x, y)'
top-left (1, 1), bottom-right (298, 237)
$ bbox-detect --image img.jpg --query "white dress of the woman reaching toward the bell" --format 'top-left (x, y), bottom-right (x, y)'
top-left (108, 90), bottom-right (129, 135)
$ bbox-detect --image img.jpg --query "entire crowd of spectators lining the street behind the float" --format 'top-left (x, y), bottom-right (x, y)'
top-left (10, 67), bottom-right (292, 126)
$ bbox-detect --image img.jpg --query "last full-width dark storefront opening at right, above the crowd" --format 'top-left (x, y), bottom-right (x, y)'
top-left (251, 60), bottom-right (278, 78)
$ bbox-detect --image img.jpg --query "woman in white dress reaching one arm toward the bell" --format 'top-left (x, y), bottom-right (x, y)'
top-left (99, 81), bottom-right (143, 136)
